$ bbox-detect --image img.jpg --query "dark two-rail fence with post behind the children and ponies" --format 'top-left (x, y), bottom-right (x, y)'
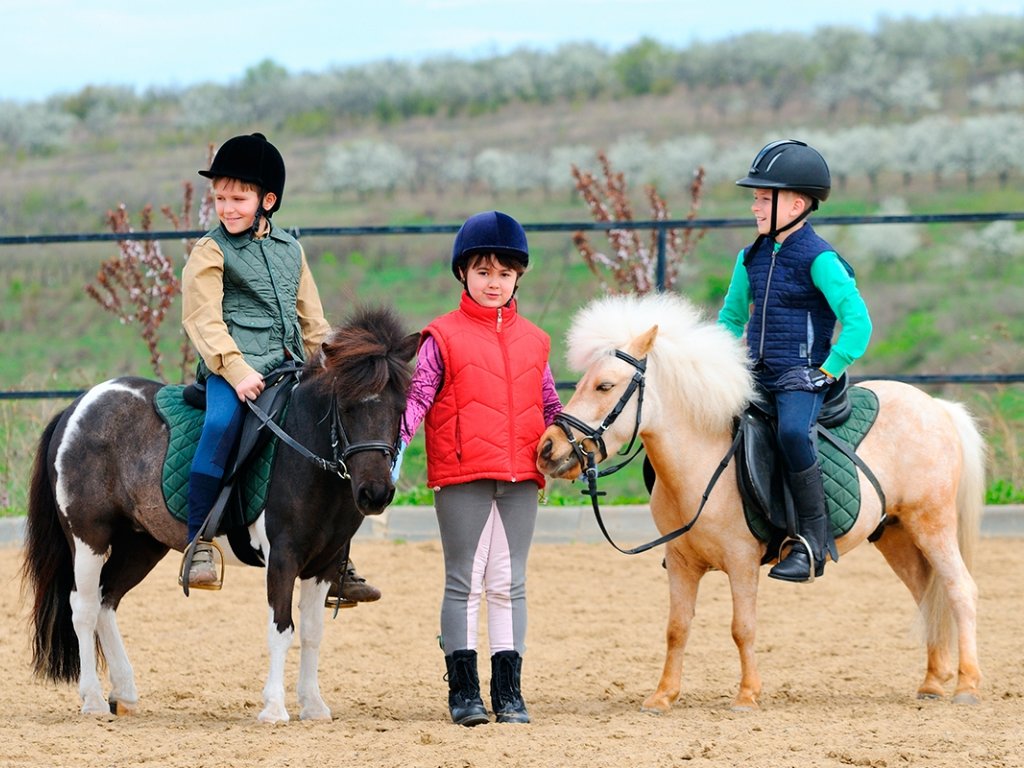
top-left (0, 211), bottom-right (1024, 400)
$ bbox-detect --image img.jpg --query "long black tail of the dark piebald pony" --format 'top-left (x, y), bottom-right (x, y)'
top-left (22, 413), bottom-right (80, 683)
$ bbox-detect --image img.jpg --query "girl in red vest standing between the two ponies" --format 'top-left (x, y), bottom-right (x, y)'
top-left (401, 211), bottom-right (562, 726)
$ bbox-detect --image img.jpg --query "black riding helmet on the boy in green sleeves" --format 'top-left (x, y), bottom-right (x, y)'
top-left (736, 138), bottom-right (831, 238)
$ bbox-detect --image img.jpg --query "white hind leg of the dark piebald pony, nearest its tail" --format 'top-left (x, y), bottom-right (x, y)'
top-left (69, 540), bottom-right (111, 715)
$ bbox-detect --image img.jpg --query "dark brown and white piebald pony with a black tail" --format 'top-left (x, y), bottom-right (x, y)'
top-left (24, 308), bottom-right (417, 722)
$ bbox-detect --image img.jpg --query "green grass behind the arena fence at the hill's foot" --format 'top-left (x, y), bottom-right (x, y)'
top-left (0, 173), bottom-right (1024, 514)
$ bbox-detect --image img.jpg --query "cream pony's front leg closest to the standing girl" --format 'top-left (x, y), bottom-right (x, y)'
top-left (640, 547), bottom-right (703, 715)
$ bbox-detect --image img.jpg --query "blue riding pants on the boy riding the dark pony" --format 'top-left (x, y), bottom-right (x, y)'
top-left (188, 376), bottom-right (245, 542)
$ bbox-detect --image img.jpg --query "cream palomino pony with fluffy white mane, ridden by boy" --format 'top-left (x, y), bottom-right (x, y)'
top-left (538, 294), bottom-right (985, 713)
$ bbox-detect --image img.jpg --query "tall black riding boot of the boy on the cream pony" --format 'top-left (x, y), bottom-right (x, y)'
top-left (768, 464), bottom-right (837, 582)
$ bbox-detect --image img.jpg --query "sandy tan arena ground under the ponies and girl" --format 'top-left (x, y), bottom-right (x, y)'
top-left (0, 539), bottom-right (1024, 768)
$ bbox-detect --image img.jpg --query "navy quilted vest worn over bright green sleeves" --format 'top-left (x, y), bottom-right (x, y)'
top-left (743, 224), bottom-right (853, 375)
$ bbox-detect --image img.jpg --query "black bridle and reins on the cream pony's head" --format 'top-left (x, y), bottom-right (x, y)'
top-left (554, 349), bottom-right (741, 555)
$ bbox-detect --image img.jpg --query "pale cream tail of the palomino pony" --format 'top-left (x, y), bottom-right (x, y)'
top-left (921, 398), bottom-right (987, 646)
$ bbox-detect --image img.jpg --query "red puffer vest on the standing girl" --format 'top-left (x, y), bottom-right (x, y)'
top-left (423, 293), bottom-right (551, 488)
